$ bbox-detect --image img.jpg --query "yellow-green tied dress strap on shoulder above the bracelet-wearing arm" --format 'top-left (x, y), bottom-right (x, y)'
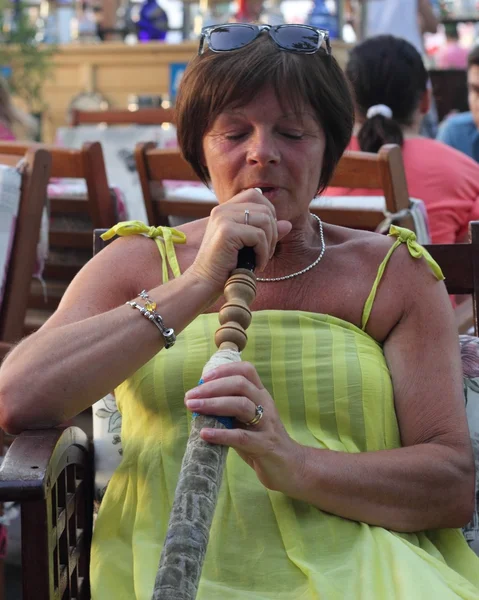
top-left (101, 221), bottom-right (186, 283)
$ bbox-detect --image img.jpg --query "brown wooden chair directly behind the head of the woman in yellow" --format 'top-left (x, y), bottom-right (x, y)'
top-left (135, 142), bottom-right (415, 231)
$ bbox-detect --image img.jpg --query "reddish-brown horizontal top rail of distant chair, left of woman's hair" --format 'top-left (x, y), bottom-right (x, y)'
top-left (71, 107), bottom-right (175, 127)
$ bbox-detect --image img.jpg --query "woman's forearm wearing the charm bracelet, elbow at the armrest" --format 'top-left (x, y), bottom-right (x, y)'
top-left (0, 274), bottom-right (216, 433)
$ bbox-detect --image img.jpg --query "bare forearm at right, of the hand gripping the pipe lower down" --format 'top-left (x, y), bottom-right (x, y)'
top-left (282, 443), bottom-right (474, 531)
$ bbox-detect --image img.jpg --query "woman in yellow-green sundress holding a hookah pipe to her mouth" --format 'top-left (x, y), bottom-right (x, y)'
top-left (0, 25), bottom-right (479, 600)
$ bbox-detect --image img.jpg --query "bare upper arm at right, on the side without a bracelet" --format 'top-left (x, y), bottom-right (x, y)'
top-left (384, 257), bottom-right (472, 460)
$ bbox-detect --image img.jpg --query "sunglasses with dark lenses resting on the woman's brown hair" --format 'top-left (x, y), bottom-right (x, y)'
top-left (198, 23), bottom-right (331, 55)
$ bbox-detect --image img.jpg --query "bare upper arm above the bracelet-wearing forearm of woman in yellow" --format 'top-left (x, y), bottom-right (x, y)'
top-left (42, 236), bottom-right (161, 329)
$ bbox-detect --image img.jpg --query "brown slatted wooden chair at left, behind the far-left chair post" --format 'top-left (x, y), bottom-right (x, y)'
top-left (0, 142), bottom-right (118, 333)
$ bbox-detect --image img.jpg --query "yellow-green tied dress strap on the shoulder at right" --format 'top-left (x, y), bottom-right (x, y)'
top-left (361, 225), bottom-right (444, 331)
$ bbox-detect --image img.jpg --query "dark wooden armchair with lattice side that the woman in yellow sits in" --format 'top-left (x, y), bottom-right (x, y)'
top-left (0, 221), bottom-right (479, 600)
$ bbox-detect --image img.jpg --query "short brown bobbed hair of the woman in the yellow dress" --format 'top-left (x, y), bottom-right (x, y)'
top-left (176, 34), bottom-right (354, 191)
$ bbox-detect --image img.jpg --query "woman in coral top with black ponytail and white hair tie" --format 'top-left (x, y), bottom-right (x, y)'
top-left (326, 35), bottom-right (479, 244)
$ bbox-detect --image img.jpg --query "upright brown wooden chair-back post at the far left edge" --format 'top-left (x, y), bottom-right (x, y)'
top-left (0, 148), bottom-right (51, 342)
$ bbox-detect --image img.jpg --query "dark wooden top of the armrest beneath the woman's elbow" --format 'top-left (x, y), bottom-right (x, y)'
top-left (0, 427), bottom-right (90, 502)
